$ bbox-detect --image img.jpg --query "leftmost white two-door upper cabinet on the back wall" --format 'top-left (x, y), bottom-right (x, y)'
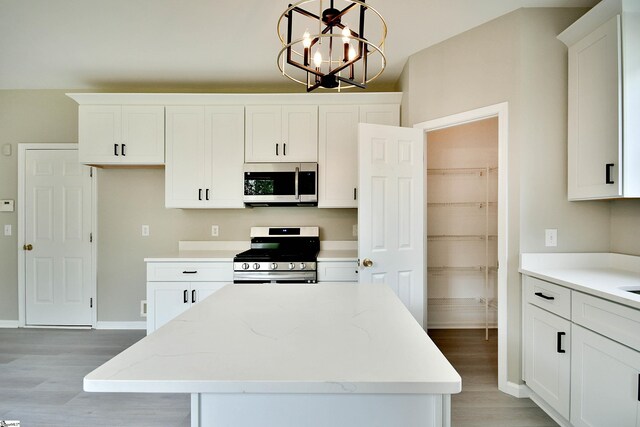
top-left (78, 105), bottom-right (164, 165)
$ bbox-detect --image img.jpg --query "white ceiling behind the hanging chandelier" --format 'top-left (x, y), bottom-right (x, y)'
top-left (0, 0), bottom-right (597, 90)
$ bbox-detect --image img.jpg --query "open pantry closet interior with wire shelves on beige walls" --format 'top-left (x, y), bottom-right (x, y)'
top-left (425, 117), bottom-right (498, 336)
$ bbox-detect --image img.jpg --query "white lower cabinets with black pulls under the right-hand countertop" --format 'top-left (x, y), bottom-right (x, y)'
top-left (523, 275), bottom-right (640, 427)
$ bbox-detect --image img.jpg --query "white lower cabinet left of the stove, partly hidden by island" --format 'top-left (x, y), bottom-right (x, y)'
top-left (147, 261), bottom-right (233, 334)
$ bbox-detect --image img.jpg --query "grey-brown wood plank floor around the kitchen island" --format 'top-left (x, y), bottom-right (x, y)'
top-left (0, 329), bottom-right (557, 427)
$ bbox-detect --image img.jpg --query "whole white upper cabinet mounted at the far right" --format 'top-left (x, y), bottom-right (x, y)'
top-left (558, 0), bottom-right (640, 200)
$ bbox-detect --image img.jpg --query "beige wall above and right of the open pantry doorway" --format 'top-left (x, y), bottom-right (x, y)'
top-left (401, 8), bottom-right (622, 383)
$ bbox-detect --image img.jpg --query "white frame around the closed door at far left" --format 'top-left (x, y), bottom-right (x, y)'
top-left (17, 142), bottom-right (98, 329)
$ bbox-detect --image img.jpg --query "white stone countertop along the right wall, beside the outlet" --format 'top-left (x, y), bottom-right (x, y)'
top-left (520, 253), bottom-right (640, 309)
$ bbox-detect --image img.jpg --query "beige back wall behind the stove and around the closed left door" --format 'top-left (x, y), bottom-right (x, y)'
top-left (0, 90), bottom-right (357, 321)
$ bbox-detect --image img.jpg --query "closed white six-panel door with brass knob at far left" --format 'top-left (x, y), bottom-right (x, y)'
top-left (24, 150), bottom-right (93, 326)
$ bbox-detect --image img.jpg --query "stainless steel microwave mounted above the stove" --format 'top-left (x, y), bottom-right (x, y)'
top-left (244, 163), bottom-right (318, 206)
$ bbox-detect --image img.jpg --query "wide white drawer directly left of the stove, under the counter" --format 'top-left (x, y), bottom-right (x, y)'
top-left (147, 261), bottom-right (233, 282)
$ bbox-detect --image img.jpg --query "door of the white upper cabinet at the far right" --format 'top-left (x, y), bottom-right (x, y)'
top-left (568, 16), bottom-right (623, 200)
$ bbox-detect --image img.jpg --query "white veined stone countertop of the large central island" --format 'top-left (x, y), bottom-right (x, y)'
top-left (84, 283), bottom-right (461, 394)
